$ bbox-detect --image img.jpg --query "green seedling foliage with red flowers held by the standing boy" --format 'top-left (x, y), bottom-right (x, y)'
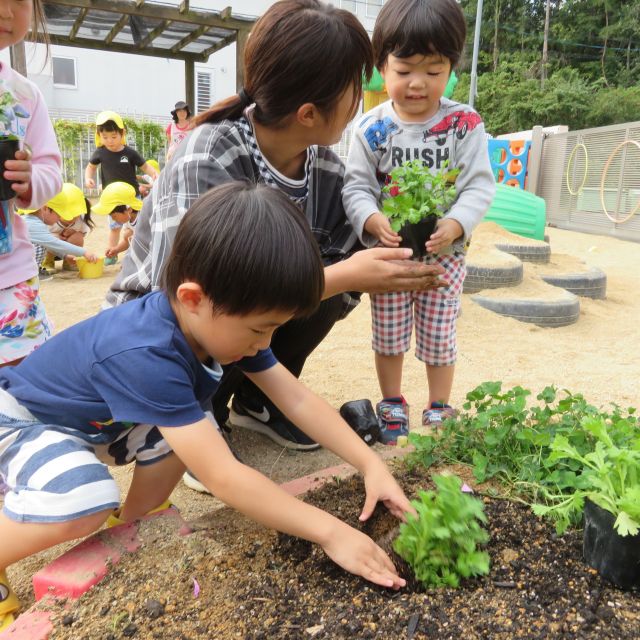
top-left (382, 160), bottom-right (460, 232)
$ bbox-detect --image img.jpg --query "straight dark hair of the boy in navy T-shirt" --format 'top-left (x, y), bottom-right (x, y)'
top-left (164, 181), bottom-right (324, 316)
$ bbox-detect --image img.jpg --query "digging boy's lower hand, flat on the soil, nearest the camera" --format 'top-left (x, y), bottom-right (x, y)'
top-left (321, 522), bottom-right (406, 589)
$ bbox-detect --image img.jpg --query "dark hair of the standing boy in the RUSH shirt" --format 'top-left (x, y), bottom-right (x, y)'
top-left (371, 0), bottom-right (467, 69)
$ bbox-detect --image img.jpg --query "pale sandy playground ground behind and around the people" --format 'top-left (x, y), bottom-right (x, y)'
top-left (10, 214), bottom-right (640, 601)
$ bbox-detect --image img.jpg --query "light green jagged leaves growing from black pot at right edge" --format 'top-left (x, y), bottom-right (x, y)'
top-left (533, 416), bottom-right (640, 536)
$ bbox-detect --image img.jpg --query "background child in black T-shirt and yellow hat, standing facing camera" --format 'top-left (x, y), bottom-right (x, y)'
top-left (84, 111), bottom-right (158, 264)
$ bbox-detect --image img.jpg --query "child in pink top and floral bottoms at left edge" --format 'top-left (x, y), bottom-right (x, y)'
top-left (0, 0), bottom-right (62, 367)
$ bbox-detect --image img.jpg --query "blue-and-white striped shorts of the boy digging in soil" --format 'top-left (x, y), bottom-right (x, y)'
top-left (0, 389), bottom-right (171, 522)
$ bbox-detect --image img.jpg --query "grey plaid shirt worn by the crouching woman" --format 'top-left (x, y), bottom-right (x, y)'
top-left (103, 118), bottom-right (361, 314)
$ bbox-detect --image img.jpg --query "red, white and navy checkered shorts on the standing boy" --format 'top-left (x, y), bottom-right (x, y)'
top-left (371, 254), bottom-right (466, 367)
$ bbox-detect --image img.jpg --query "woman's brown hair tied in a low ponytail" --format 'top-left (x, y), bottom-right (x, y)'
top-left (195, 0), bottom-right (373, 127)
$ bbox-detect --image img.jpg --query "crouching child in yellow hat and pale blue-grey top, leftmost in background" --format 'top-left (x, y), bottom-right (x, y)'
top-left (18, 183), bottom-right (98, 280)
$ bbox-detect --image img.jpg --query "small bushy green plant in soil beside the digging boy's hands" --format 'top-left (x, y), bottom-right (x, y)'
top-left (393, 476), bottom-right (489, 587)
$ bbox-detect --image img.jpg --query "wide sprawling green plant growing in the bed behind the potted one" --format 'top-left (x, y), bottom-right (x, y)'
top-left (407, 382), bottom-right (638, 530)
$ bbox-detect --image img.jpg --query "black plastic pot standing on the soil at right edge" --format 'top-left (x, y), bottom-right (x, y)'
top-left (582, 500), bottom-right (640, 590)
